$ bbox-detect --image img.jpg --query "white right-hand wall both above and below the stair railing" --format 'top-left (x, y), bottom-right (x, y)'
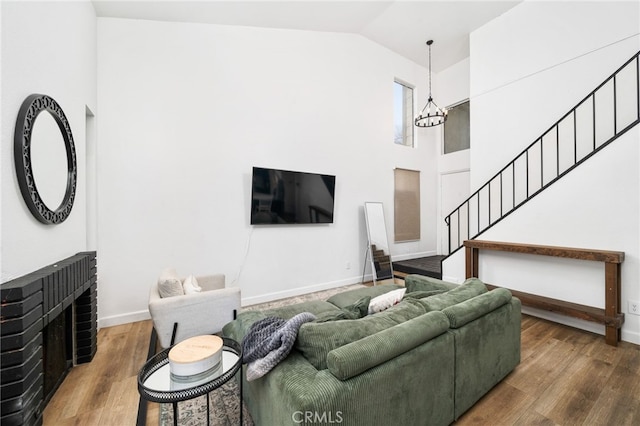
top-left (443, 2), bottom-right (640, 343)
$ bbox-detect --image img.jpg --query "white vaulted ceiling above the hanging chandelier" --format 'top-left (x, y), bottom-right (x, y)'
top-left (93, 0), bottom-right (522, 72)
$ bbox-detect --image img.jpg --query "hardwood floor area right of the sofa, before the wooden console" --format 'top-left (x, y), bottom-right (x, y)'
top-left (456, 315), bottom-right (640, 425)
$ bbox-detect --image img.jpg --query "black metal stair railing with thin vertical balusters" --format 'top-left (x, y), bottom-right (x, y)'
top-left (445, 52), bottom-right (640, 256)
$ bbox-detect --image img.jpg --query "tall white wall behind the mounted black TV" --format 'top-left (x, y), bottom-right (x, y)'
top-left (98, 18), bottom-right (437, 326)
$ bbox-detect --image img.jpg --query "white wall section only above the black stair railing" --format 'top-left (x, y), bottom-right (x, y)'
top-left (470, 1), bottom-right (640, 188)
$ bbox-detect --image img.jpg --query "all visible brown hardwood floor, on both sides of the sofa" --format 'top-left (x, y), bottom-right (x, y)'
top-left (44, 315), bottom-right (640, 426)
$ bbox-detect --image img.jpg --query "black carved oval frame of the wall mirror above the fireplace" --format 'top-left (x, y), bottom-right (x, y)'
top-left (13, 94), bottom-right (78, 225)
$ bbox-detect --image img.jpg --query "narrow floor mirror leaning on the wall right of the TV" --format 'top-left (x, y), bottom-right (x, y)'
top-left (364, 202), bottom-right (393, 285)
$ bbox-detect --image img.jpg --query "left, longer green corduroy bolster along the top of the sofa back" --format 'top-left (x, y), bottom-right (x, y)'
top-left (327, 311), bottom-right (449, 380)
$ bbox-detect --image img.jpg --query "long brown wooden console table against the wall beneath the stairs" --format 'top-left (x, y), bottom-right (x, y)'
top-left (464, 240), bottom-right (624, 346)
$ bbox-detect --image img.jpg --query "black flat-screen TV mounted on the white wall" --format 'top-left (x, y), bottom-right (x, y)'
top-left (251, 167), bottom-right (336, 225)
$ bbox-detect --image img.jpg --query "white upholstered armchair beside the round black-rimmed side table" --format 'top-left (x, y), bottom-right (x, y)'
top-left (149, 274), bottom-right (240, 348)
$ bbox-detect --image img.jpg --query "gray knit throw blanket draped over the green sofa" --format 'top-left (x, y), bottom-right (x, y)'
top-left (242, 312), bottom-right (316, 381)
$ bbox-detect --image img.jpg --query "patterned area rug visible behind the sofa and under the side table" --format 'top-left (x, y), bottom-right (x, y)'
top-left (160, 284), bottom-right (364, 426)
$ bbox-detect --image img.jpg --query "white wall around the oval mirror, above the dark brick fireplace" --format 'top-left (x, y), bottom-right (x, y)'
top-left (0, 1), bottom-right (96, 282)
